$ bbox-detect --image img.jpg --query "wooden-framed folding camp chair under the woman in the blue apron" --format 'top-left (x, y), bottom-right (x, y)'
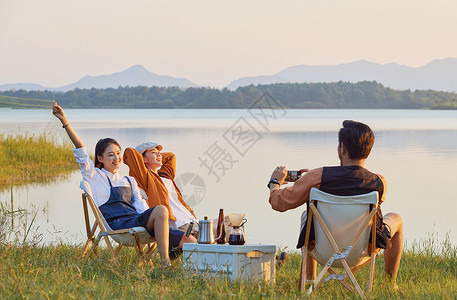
top-left (79, 180), bottom-right (156, 258)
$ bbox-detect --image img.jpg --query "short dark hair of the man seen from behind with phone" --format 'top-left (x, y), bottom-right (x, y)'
top-left (338, 120), bottom-right (374, 159)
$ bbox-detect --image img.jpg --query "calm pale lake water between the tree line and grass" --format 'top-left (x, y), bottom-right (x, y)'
top-left (0, 109), bottom-right (457, 249)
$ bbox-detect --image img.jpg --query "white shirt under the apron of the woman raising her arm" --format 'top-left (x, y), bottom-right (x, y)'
top-left (73, 147), bottom-right (149, 213)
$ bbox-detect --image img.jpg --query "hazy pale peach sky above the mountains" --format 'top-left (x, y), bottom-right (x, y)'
top-left (0, 0), bottom-right (457, 87)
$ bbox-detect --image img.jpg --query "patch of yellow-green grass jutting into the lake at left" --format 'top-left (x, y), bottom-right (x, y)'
top-left (0, 134), bottom-right (77, 190)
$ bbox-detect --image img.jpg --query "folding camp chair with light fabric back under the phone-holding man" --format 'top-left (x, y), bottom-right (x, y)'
top-left (300, 188), bottom-right (378, 297)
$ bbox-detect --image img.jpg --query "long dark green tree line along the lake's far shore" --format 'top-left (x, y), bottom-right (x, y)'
top-left (0, 81), bottom-right (457, 109)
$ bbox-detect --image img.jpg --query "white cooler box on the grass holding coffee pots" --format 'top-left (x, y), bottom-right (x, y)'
top-left (183, 243), bottom-right (276, 283)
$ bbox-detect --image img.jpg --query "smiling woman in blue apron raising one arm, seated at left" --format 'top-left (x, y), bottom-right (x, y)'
top-left (52, 103), bottom-right (195, 267)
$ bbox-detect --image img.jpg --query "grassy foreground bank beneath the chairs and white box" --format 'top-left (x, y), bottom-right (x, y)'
top-left (0, 237), bottom-right (457, 299)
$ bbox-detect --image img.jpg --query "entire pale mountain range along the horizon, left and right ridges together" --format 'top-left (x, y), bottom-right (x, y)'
top-left (0, 58), bottom-right (457, 92)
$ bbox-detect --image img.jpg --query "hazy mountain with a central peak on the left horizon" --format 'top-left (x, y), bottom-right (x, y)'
top-left (0, 65), bottom-right (197, 92)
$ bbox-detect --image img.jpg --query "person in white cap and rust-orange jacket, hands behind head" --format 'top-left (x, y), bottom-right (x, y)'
top-left (124, 142), bottom-right (197, 230)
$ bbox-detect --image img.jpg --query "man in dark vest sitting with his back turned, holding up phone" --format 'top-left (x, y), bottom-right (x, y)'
top-left (268, 120), bottom-right (403, 284)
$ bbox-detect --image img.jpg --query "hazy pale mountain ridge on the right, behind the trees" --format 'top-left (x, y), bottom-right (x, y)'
top-left (227, 58), bottom-right (457, 92)
